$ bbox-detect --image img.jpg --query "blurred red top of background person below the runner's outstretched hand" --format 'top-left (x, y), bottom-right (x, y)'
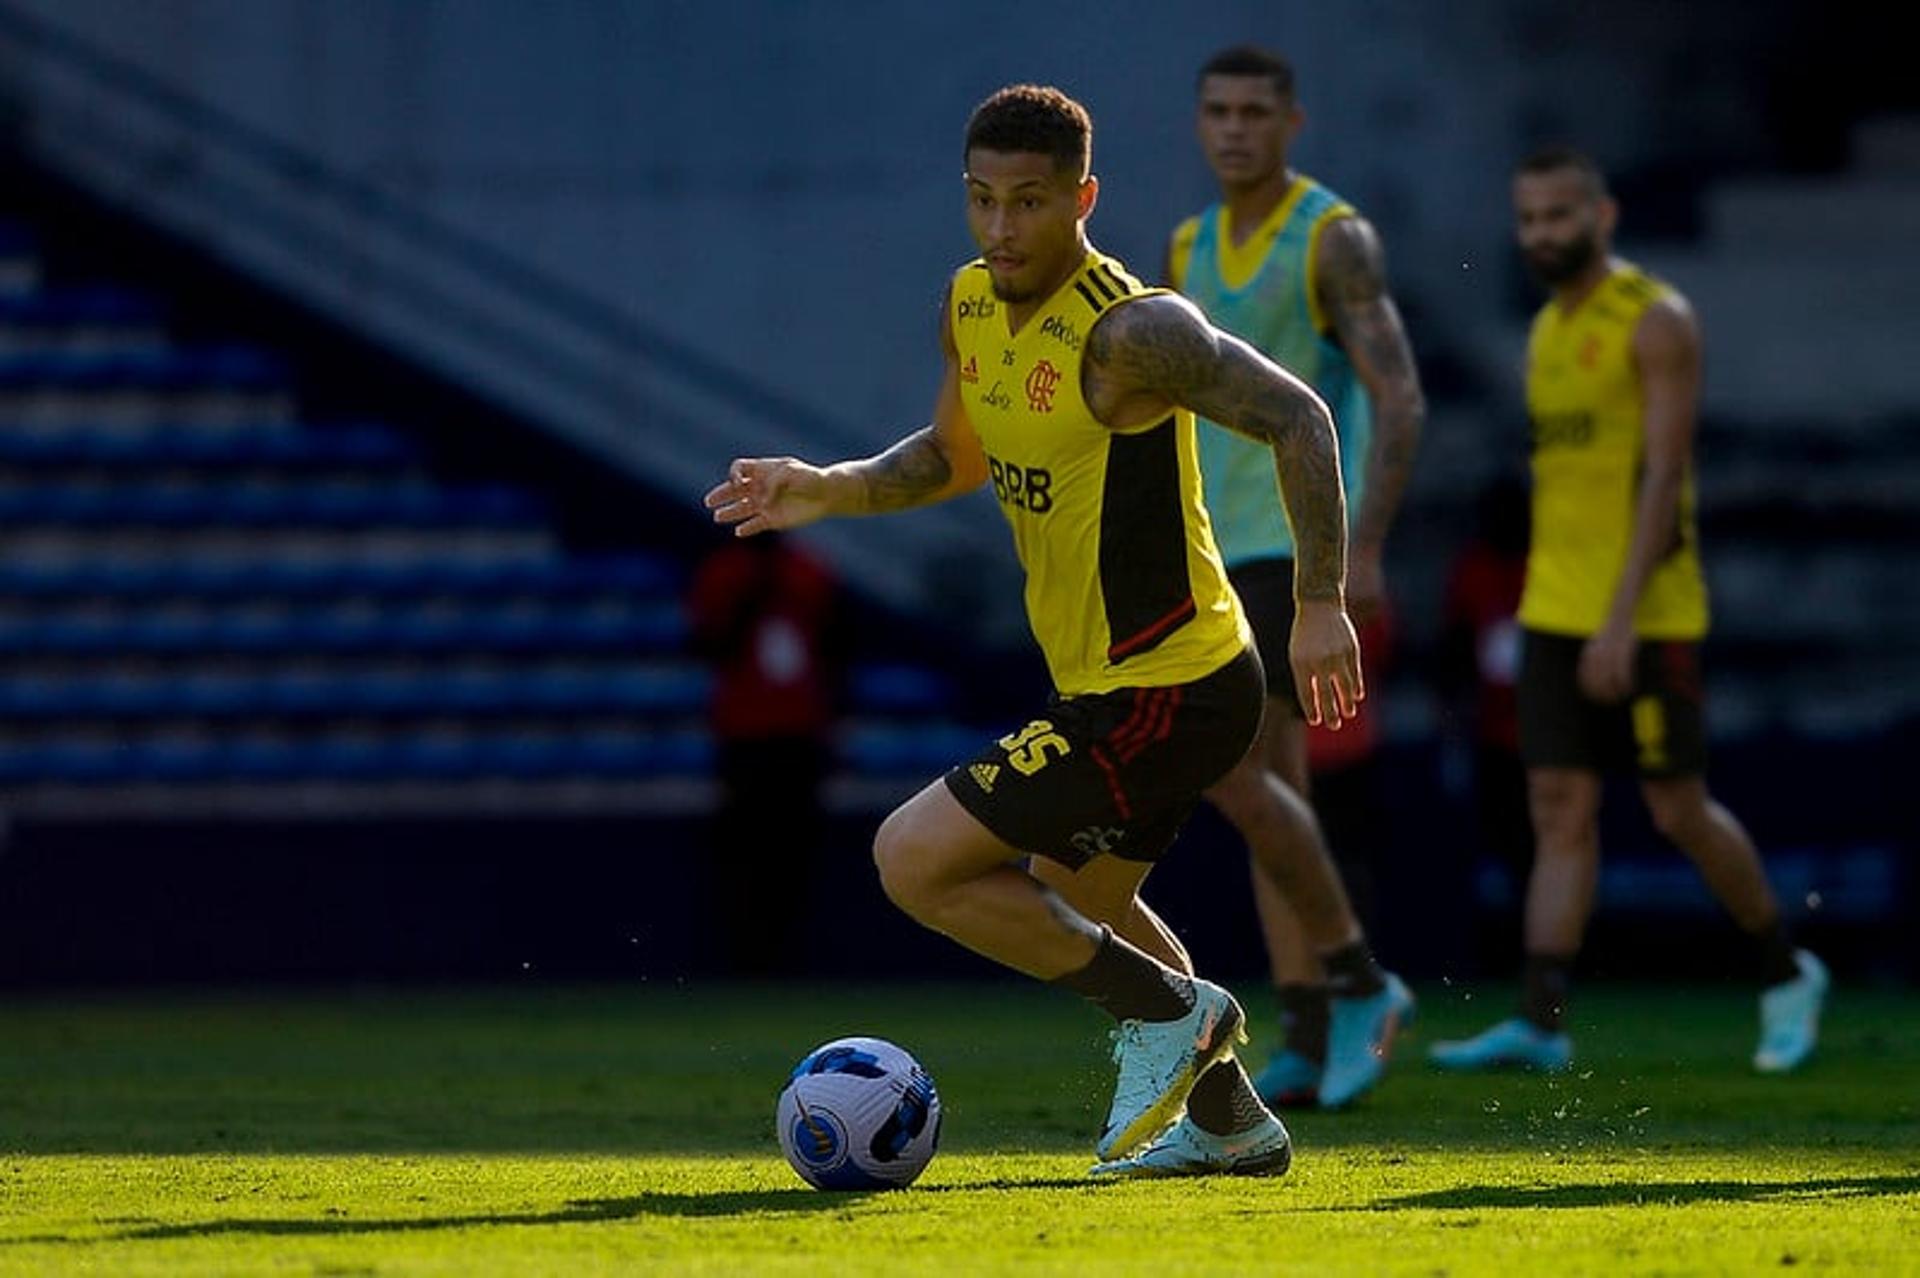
top-left (687, 533), bottom-right (839, 741)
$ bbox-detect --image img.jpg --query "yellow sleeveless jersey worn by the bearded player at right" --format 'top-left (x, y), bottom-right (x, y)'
top-left (1521, 263), bottom-right (1707, 639)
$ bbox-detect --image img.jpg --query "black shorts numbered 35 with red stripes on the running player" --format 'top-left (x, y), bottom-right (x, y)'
top-left (947, 649), bottom-right (1265, 869)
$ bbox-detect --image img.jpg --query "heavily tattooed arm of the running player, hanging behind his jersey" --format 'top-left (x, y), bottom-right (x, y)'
top-left (1081, 294), bottom-right (1365, 727)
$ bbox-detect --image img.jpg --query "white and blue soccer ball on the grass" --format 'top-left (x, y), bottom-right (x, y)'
top-left (774, 1038), bottom-right (941, 1190)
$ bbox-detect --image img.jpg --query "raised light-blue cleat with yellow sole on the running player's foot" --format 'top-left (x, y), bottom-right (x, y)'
top-left (1096, 981), bottom-right (1246, 1163)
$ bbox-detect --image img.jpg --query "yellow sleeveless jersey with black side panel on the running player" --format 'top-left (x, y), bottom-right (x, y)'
top-left (947, 243), bottom-right (1244, 697)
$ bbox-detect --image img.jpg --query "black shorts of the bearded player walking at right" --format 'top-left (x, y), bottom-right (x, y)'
top-left (1517, 629), bottom-right (1707, 779)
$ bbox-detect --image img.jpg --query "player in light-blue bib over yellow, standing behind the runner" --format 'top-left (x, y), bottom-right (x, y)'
top-left (1167, 46), bottom-right (1425, 1107)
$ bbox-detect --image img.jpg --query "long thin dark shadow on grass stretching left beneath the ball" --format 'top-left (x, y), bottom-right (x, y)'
top-left (0, 1178), bottom-right (1089, 1247)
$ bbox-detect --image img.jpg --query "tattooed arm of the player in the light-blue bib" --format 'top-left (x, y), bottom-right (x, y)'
top-left (1313, 217), bottom-right (1427, 616)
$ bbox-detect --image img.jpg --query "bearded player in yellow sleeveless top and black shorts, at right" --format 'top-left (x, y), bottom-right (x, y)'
top-left (1432, 148), bottom-right (1828, 1073)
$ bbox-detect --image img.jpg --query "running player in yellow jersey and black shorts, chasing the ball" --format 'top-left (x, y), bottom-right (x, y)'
top-left (707, 84), bottom-right (1363, 1176)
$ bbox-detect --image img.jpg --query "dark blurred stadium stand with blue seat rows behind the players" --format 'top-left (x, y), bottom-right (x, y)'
top-left (0, 0), bottom-right (1920, 988)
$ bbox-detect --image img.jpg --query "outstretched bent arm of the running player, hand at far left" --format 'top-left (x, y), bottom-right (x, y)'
top-left (707, 284), bottom-right (987, 537)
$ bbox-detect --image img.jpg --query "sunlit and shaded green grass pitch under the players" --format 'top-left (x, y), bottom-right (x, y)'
top-left (0, 982), bottom-right (1920, 1278)
